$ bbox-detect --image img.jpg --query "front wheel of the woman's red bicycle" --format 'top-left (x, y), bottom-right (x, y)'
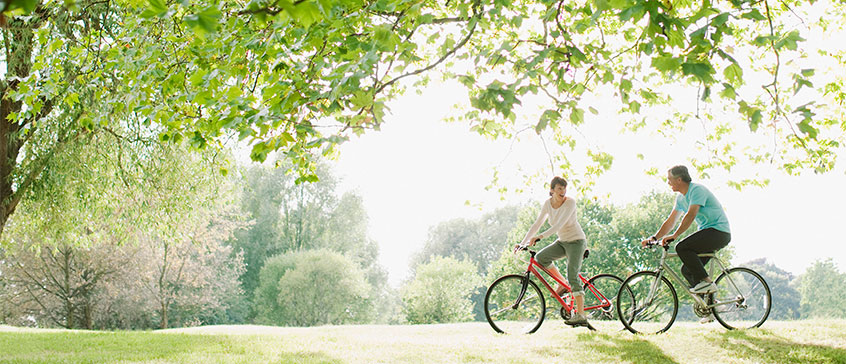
top-left (485, 274), bottom-right (546, 334)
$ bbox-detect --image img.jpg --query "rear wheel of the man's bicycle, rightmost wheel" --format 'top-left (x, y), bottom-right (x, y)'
top-left (711, 268), bottom-right (772, 330)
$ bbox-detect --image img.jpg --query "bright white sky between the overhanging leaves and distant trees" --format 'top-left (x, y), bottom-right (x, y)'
top-left (334, 80), bottom-right (846, 286)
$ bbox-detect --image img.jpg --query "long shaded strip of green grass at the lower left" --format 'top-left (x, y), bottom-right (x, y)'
top-left (0, 332), bottom-right (343, 364)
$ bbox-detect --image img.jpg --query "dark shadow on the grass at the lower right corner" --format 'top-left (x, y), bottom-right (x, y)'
top-left (708, 329), bottom-right (846, 364)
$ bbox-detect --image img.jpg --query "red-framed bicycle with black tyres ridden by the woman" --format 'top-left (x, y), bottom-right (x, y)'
top-left (485, 245), bottom-right (623, 334)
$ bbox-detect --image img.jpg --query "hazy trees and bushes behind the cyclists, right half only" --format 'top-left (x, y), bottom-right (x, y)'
top-left (403, 193), bottom-right (846, 323)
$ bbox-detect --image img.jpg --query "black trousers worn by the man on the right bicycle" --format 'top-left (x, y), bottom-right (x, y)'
top-left (676, 228), bottom-right (731, 286)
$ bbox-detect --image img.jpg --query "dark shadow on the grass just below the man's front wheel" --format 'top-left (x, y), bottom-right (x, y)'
top-left (578, 333), bottom-right (677, 364)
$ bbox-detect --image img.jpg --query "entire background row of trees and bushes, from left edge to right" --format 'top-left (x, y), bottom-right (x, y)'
top-left (0, 144), bottom-right (846, 329)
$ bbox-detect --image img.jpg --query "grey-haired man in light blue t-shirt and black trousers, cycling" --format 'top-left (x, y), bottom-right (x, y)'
top-left (641, 166), bottom-right (731, 310)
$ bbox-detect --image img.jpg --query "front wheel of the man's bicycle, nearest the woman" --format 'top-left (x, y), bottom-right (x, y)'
top-left (617, 271), bottom-right (679, 334)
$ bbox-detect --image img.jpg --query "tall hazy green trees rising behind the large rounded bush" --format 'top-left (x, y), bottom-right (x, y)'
top-left (231, 157), bottom-right (387, 300)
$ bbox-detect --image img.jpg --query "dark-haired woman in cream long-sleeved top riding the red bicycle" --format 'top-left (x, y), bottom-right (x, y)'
top-left (521, 177), bottom-right (587, 325)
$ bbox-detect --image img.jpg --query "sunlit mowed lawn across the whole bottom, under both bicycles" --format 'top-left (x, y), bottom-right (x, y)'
top-left (0, 319), bottom-right (846, 364)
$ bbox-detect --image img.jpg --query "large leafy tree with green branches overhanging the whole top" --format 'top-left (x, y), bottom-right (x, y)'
top-left (0, 0), bottom-right (846, 239)
